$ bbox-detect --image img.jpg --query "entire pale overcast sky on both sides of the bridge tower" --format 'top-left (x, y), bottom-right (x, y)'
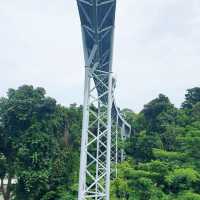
top-left (0, 0), bottom-right (200, 111)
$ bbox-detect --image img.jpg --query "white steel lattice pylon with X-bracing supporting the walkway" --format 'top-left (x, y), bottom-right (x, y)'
top-left (79, 46), bottom-right (113, 200)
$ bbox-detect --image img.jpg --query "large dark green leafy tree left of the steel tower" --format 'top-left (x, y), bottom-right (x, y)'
top-left (0, 85), bottom-right (81, 200)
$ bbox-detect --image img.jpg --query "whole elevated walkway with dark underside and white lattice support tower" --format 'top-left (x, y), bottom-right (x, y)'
top-left (77, 0), bottom-right (130, 200)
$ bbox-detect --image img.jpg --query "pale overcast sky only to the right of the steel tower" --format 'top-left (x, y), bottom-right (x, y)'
top-left (114, 0), bottom-right (200, 110)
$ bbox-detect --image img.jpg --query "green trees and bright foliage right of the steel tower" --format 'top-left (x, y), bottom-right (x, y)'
top-left (115, 88), bottom-right (200, 200)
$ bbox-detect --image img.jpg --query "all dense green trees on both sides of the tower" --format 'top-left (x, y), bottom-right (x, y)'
top-left (0, 85), bottom-right (200, 200)
